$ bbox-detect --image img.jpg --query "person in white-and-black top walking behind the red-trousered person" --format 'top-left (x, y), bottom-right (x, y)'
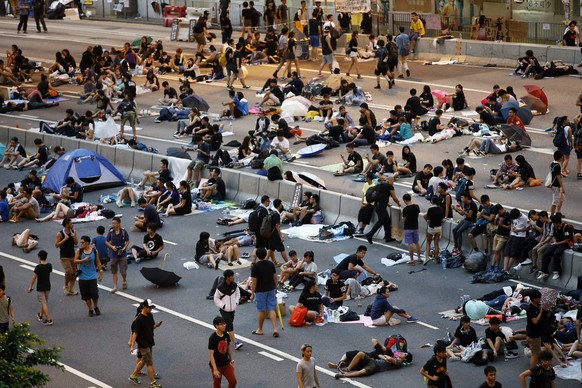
top-left (214, 269), bottom-right (243, 350)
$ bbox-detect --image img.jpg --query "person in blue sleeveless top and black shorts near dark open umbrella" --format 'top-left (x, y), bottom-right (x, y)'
top-left (74, 236), bottom-right (103, 317)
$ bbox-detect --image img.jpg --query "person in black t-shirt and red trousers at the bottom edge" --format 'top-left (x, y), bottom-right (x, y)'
top-left (208, 317), bottom-right (237, 388)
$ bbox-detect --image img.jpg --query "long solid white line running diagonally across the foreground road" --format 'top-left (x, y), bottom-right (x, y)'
top-left (0, 252), bottom-right (372, 388)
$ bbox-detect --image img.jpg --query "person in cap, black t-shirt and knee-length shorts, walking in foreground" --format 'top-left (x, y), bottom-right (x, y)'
top-left (127, 299), bottom-right (162, 388)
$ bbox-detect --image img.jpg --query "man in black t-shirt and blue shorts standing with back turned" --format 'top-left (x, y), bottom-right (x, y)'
top-left (250, 248), bottom-right (279, 338)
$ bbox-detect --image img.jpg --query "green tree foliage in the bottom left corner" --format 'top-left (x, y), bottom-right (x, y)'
top-left (0, 323), bottom-right (64, 388)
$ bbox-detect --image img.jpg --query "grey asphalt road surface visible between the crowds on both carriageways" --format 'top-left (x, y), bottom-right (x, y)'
top-left (0, 19), bottom-right (580, 387)
